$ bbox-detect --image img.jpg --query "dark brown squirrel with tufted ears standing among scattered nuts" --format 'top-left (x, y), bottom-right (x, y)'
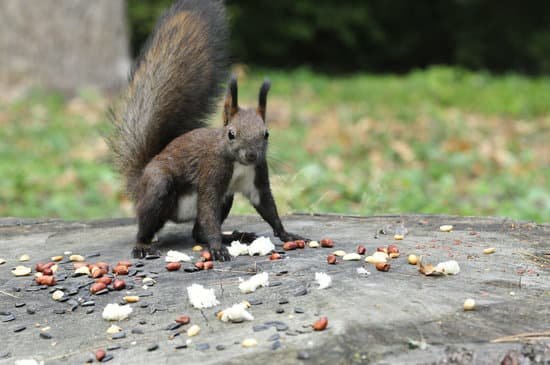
top-left (108, 0), bottom-right (303, 261)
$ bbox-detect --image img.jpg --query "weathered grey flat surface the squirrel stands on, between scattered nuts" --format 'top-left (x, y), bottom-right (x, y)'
top-left (0, 215), bottom-right (550, 364)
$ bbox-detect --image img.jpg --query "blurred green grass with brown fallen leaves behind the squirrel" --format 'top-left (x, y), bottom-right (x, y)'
top-left (0, 67), bottom-right (550, 222)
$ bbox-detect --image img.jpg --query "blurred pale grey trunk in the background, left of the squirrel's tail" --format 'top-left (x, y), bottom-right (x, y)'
top-left (0, 0), bottom-right (130, 92)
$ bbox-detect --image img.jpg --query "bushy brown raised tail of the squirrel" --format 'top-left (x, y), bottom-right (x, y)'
top-left (107, 0), bottom-right (229, 201)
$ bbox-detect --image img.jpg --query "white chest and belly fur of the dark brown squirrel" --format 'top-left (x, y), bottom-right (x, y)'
top-left (178, 162), bottom-right (260, 222)
